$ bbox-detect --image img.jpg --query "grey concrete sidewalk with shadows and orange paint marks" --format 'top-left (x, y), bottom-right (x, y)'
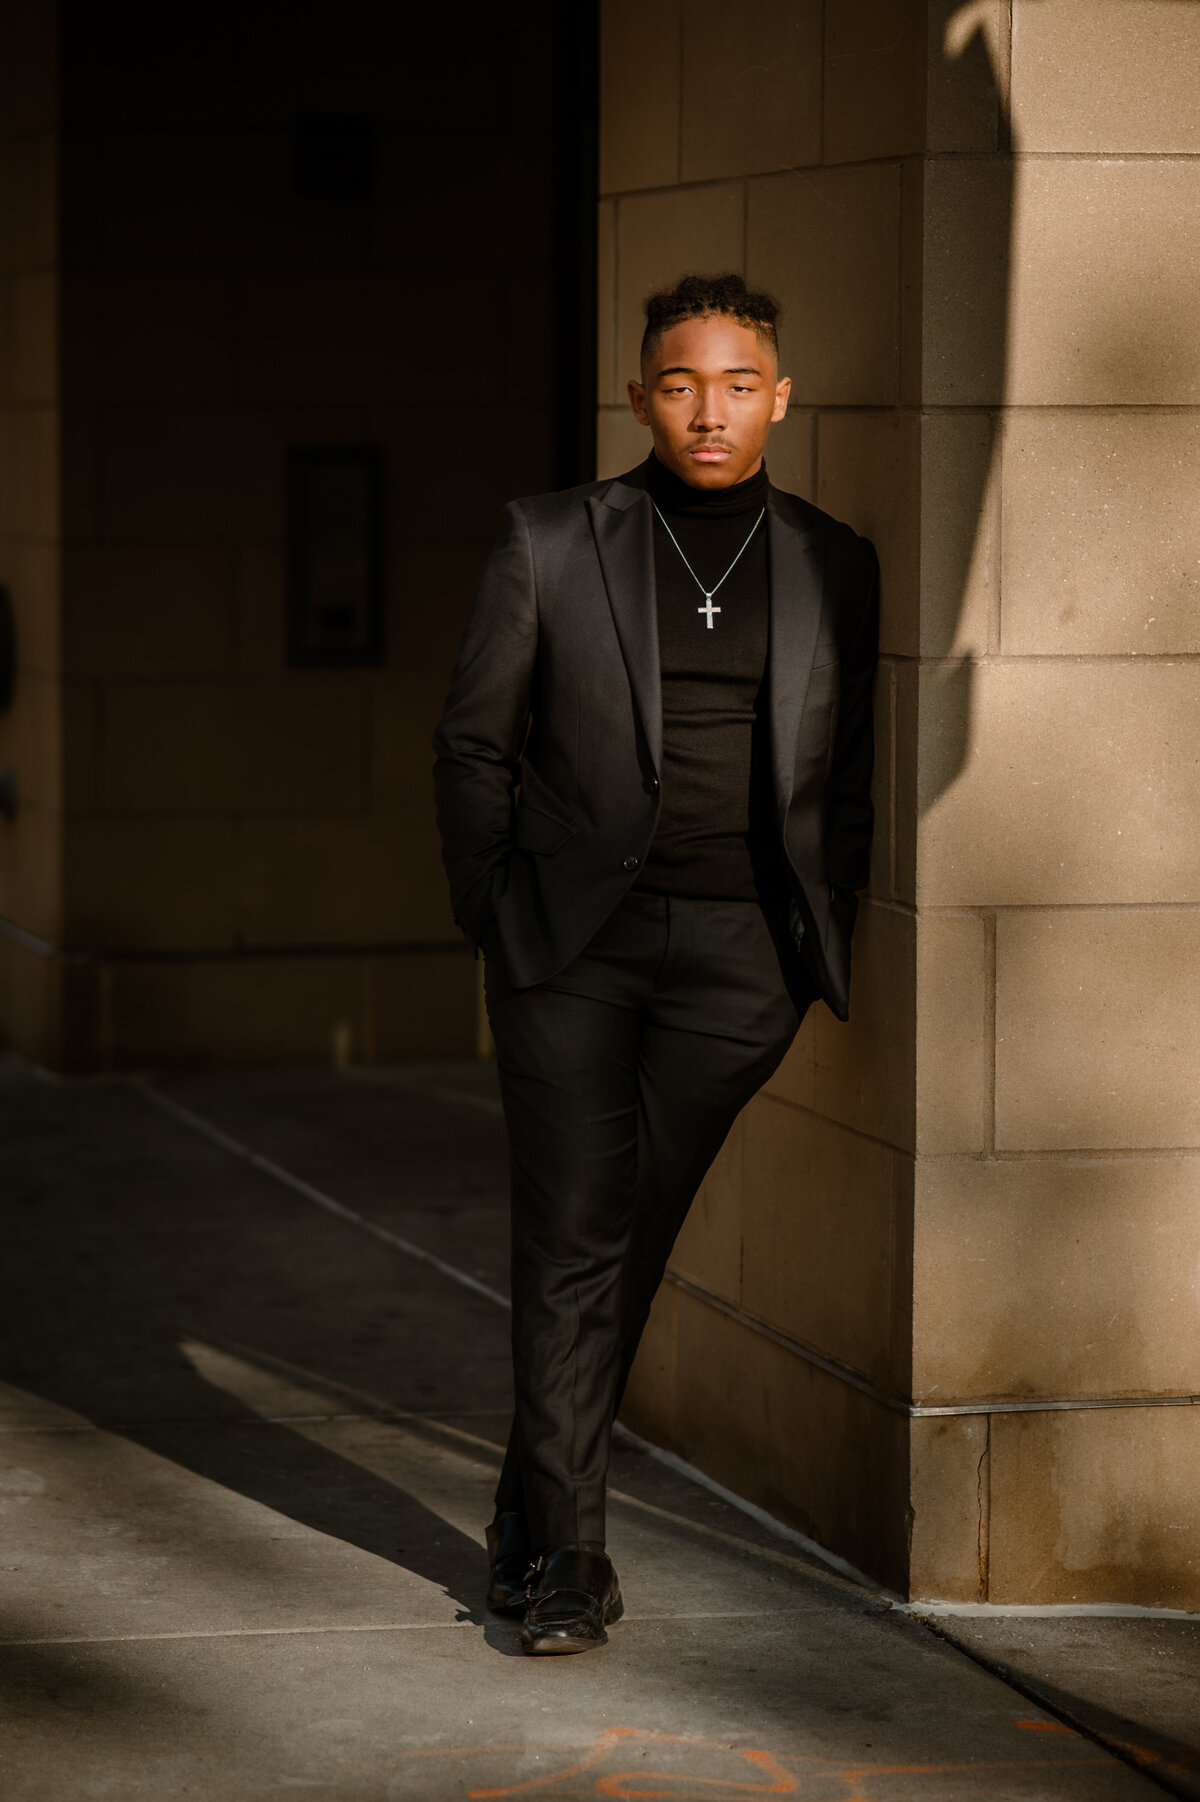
top-left (0, 1063), bottom-right (1200, 1802)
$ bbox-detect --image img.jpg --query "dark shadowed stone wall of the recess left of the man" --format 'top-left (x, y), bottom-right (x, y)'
top-left (0, 0), bottom-right (553, 1069)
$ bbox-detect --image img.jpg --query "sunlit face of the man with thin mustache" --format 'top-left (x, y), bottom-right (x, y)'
top-left (629, 314), bottom-right (791, 488)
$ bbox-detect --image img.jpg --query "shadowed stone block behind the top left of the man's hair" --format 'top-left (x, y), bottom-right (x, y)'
top-left (616, 182), bottom-right (746, 393)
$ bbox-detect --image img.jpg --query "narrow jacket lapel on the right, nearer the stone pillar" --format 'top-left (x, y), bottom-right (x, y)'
top-left (768, 488), bottom-right (823, 815)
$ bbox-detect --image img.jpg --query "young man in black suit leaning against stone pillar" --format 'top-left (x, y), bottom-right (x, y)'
top-left (434, 276), bottom-right (877, 1652)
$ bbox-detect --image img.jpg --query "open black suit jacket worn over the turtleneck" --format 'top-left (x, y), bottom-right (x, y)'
top-left (434, 467), bottom-right (879, 1020)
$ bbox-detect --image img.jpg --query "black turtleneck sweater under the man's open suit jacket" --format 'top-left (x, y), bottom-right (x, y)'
top-left (638, 452), bottom-right (784, 901)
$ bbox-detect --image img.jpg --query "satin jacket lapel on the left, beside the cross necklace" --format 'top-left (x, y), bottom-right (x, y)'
top-left (587, 481), bottom-right (663, 769)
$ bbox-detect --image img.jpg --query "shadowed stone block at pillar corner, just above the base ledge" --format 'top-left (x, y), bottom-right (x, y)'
top-left (730, 1096), bottom-right (894, 1388)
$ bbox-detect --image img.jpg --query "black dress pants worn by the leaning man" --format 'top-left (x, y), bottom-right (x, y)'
top-left (485, 888), bottom-right (813, 1550)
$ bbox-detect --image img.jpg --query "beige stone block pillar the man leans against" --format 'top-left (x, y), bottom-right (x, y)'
top-left (598, 0), bottom-right (1200, 1609)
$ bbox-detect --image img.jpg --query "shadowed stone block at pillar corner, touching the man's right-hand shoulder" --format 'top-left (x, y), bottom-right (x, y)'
top-left (816, 413), bottom-right (923, 656)
